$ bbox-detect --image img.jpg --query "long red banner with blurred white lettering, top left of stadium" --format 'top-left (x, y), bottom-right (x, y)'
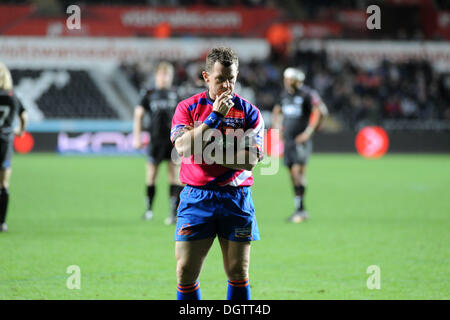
top-left (0, 5), bottom-right (280, 37)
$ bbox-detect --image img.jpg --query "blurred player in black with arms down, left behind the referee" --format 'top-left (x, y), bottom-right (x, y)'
top-left (133, 62), bottom-right (183, 224)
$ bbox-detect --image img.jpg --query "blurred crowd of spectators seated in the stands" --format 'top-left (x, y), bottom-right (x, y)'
top-left (121, 46), bottom-right (450, 129)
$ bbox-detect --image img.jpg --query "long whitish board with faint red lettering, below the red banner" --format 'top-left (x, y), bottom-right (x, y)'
top-left (0, 37), bottom-right (270, 67)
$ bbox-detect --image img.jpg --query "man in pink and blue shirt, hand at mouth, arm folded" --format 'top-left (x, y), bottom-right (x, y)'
top-left (171, 47), bottom-right (264, 300)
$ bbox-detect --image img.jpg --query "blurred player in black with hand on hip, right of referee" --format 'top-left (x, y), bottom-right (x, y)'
top-left (273, 68), bottom-right (328, 223)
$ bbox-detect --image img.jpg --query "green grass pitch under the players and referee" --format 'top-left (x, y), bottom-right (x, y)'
top-left (0, 154), bottom-right (450, 300)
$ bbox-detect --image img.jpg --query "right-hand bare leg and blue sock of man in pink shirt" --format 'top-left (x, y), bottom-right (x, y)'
top-left (219, 237), bottom-right (250, 300)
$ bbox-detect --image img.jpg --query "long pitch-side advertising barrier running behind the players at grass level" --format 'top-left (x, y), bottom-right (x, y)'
top-left (15, 120), bottom-right (450, 156)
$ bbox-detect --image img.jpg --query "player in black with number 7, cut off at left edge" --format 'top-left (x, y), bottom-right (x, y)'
top-left (0, 63), bottom-right (27, 232)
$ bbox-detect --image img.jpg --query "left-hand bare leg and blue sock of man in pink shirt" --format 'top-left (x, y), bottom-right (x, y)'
top-left (175, 237), bottom-right (214, 300)
